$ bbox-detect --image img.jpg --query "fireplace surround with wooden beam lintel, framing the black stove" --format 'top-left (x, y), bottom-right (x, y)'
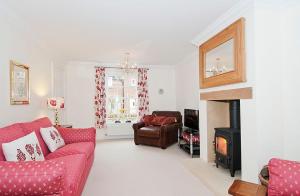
top-left (199, 87), bottom-right (253, 181)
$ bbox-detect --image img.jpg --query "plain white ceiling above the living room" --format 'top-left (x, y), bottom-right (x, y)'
top-left (2, 0), bottom-right (239, 65)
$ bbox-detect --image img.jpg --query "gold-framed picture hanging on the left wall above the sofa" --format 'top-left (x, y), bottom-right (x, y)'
top-left (10, 60), bottom-right (30, 105)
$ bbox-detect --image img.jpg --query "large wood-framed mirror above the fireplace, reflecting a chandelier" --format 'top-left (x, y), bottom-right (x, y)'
top-left (199, 18), bottom-right (246, 88)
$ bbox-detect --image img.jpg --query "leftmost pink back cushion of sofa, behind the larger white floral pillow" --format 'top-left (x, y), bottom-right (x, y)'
top-left (0, 123), bottom-right (25, 161)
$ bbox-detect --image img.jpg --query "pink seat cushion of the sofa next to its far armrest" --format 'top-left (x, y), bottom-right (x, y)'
top-left (46, 142), bottom-right (94, 159)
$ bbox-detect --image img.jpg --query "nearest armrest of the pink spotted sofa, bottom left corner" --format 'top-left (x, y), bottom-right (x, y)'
top-left (0, 160), bottom-right (65, 195)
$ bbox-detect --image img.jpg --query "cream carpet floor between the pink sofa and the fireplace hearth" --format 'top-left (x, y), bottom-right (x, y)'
top-left (83, 140), bottom-right (214, 196)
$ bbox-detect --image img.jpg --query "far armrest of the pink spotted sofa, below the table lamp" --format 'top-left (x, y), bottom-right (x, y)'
top-left (57, 127), bottom-right (96, 145)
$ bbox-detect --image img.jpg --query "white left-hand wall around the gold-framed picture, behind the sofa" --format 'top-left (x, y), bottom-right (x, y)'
top-left (0, 4), bottom-right (51, 126)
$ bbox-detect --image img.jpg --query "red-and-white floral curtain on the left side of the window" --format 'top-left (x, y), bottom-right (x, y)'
top-left (94, 67), bottom-right (106, 129)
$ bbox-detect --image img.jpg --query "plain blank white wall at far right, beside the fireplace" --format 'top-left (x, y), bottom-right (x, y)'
top-left (246, 0), bottom-right (300, 179)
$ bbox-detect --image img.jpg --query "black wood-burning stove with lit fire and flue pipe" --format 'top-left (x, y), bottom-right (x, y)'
top-left (214, 100), bottom-right (241, 177)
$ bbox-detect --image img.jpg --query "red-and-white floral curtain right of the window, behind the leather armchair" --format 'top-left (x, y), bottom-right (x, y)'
top-left (138, 68), bottom-right (149, 119)
